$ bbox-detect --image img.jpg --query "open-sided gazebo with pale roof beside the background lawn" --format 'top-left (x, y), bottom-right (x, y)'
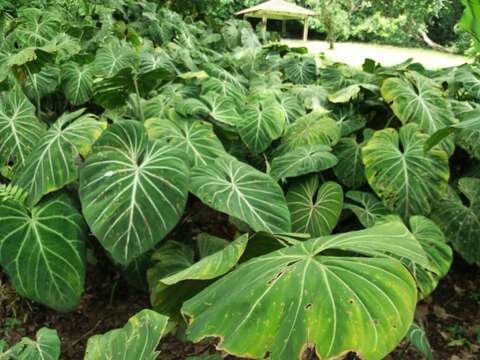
top-left (235, 0), bottom-right (316, 41)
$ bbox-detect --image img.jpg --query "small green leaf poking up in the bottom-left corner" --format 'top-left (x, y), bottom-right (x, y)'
top-left (0, 327), bottom-right (60, 360)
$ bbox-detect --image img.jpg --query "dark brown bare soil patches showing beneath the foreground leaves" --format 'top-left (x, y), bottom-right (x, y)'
top-left (0, 204), bottom-right (480, 360)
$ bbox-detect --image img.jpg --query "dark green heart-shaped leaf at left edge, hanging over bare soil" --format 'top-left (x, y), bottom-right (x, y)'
top-left (0, 195), bottom-right (87, 311)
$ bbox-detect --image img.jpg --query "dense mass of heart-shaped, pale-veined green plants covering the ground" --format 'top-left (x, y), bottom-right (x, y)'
top-left (0, 1), bottom-right (480, 360)
